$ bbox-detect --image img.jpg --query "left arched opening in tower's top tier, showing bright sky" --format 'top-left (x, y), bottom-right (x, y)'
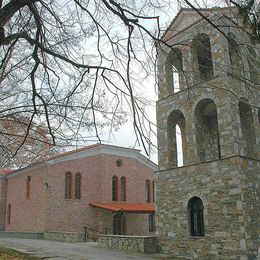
top-left (166, 48), bottom-right (183, 93)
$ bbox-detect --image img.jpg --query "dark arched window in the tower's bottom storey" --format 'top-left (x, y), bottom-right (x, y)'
top-left (188, 197), bottom-right (205, 236)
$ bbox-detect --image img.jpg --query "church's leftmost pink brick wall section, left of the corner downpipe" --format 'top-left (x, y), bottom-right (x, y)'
top-left (5, 167), bottom-right (46, 232)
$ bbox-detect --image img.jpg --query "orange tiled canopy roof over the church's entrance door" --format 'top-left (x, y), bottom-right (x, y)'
top-left (89, 202), bottom-right (155, 213)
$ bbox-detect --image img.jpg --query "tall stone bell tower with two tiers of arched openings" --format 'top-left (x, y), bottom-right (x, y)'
top-left (155, 8), bottom-right (260, 260)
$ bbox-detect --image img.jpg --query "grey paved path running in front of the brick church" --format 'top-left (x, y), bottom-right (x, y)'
top-left (0, 238), bottom-right (160, 260)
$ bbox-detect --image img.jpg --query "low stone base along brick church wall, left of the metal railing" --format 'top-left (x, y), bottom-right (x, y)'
top-left (44, 231), bottom-right (86, 242)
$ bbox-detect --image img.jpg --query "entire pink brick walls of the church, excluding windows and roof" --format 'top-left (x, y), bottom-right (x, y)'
top-left (3, 150), bottom-right (153, 234)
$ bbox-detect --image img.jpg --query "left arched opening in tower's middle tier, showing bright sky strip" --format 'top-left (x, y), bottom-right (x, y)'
top-left (167, 110), bottom-right (186, 167)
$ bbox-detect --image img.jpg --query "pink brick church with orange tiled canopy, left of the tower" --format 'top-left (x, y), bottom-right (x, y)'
top-left (0, 144), bottom-right (157, 241)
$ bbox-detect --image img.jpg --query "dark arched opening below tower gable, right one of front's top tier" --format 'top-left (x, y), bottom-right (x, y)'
top-left (192, 33), bottom-right (214, 80)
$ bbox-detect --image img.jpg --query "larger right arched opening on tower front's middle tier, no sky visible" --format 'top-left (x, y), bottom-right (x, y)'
top-left (195, 99), bottom-right (221, 162)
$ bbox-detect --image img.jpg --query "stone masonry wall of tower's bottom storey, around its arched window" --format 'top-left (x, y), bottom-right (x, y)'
top-left (155, 156), bottom-right (260, 260)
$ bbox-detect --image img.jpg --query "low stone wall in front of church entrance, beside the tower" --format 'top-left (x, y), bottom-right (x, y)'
top-left (98, 235), bottom-right (158, 254)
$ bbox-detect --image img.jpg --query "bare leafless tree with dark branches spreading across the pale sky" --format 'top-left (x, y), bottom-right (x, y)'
top-left (0, 0), bottom-right (259, 168)
